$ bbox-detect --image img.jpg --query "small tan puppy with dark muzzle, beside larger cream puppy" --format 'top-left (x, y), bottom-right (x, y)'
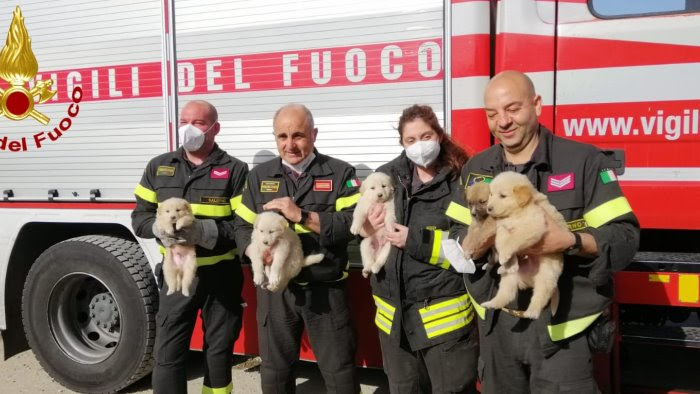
top-left (462, 182), bottom-right (496, 269)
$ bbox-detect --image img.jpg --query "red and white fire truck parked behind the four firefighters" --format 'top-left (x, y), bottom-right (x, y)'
top-left (0, 0), bottom-right (700, 392)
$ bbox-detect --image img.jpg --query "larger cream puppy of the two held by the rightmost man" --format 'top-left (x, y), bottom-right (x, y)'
top-left (483, 171), bottom-right (568, 319)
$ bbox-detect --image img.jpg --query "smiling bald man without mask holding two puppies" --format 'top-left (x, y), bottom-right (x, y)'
top-left (447, 71), bottom-right (639, 393)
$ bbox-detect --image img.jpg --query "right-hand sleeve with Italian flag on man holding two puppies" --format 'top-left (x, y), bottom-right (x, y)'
top-left (583, 152), bottom-right (639, 278)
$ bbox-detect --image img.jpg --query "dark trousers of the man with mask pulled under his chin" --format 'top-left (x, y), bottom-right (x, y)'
top-left (256, 281), bottom-right (360, 394)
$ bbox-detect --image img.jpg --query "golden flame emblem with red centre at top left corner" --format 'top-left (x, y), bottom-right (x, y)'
top-left (0, 6), bottom-right (56, 125)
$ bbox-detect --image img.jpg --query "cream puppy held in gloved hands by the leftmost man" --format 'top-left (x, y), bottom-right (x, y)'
top-left (156, 197), bottom-right (197, 297)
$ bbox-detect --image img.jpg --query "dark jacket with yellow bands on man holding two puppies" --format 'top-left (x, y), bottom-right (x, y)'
top-left (447, 126), bottom-right (639, 346)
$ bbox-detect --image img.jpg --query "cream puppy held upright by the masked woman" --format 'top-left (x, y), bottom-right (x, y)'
top-left (350, 172), bottom-right (396, 278)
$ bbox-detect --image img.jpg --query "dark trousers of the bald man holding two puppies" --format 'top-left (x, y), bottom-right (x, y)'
top-left (479, 311), bottom-right (599, 394)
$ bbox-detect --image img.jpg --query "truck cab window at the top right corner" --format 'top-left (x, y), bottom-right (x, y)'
top-left (588, 0), bottom-right (700, 19)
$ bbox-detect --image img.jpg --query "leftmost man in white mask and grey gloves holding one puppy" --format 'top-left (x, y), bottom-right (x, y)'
top-left (132, 101), bottom-right (248, 394)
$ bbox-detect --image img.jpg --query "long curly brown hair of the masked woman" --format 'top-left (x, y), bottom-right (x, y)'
top-left (399, 104), bottom-right (469, 176)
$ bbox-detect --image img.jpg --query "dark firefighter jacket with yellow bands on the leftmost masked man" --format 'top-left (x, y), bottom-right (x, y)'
top-left (131, 146), bottom-right (248, 266)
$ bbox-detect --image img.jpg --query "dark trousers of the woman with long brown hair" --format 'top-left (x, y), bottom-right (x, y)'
top-left (379, 324), bottom-right (479, 394)
